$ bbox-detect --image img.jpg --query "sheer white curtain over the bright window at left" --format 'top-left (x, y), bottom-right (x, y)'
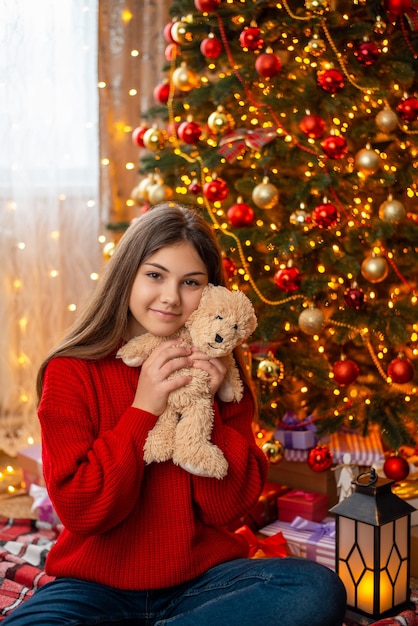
top-left (0, 0), bottom-right (102, 455)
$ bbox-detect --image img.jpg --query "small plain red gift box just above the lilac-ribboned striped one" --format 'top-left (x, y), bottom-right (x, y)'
top-left (277, 489), bottom-right (329, 522)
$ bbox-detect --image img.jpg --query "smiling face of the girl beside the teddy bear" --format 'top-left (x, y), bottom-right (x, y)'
top-left (125, 242), bottom-right (208, 339)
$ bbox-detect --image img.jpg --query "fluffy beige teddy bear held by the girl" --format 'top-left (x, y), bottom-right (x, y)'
top-left (116, 284), bottom-right (257, 479)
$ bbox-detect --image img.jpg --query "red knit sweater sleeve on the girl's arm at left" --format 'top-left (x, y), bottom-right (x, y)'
top-left (39, 358), bottom-right (157, 534)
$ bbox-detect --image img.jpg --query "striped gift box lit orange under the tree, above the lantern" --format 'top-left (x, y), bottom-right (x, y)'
top-left (328, 427), bottom-right (384, 466)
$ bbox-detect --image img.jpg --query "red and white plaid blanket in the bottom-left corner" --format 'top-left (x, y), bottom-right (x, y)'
top-left (0, 518), bottom-right (60, 621)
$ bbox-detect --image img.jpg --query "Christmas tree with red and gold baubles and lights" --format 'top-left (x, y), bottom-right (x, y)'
top-left (124, 0), bottom-right (418, 450)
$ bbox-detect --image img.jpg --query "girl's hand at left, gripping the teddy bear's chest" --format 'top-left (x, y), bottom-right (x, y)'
top-left (132, 339), bottom-right (193, 415)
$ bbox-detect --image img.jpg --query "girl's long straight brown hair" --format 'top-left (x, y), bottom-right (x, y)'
top-left (37, 202), bottom-right (255, 398)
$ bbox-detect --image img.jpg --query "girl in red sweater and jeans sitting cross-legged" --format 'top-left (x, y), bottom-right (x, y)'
top-left (5, 203), bottom-right (345, 626)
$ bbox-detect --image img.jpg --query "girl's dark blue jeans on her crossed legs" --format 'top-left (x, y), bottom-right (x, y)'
top-left (2, 558), bottom-right (345, 626)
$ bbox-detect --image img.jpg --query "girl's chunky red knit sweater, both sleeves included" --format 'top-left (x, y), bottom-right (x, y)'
top-left (39, 354), bottom-right (267, 589)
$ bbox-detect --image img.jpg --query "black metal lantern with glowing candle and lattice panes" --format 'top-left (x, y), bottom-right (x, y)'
top-left (331, 468), bottom-right (415, 621)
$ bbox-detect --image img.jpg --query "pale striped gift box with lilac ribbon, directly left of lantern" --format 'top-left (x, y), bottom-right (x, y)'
top-left (259, 517), bottom-right (335, 570)
